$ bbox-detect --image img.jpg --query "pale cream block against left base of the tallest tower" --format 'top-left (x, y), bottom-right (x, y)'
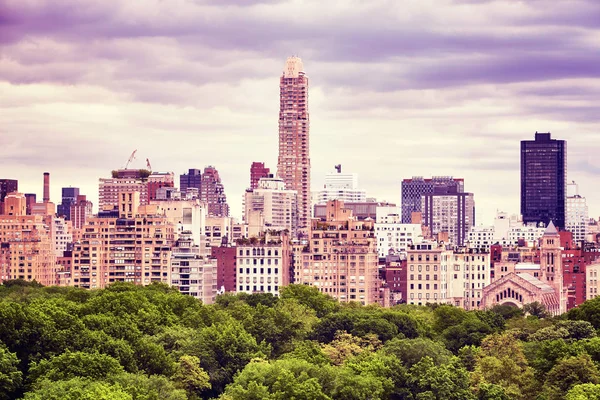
top-left (244, 177), bottom-right (298, 235)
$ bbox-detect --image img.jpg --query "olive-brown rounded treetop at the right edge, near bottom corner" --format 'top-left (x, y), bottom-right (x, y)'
top-left (545, 354), bottom-right (600, 400)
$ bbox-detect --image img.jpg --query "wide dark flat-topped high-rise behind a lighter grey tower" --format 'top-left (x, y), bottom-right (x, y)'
top-left (402, 176), bottom-right (465, 224)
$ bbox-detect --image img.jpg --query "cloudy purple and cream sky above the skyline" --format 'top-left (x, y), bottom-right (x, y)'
top-left (0, 0), bottom-right (600, 224)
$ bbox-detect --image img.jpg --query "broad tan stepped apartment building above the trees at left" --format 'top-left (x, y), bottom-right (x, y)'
top-left (69, 192), bottom-right (175, 289)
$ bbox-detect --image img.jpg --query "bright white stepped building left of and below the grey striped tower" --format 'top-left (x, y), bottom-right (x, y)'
top-left (375, 206), bottom-right (423, 258)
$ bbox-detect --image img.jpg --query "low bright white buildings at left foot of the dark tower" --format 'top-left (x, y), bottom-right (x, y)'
top-left (468, 212), bottom-right (546, 251)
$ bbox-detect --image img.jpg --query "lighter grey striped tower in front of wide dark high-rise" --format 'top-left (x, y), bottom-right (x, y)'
top-left (421, 186), bottom-right (475, 246)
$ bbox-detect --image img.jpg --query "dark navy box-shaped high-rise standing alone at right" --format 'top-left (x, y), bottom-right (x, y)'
top-left (521, 132), bottom-right (567, 229)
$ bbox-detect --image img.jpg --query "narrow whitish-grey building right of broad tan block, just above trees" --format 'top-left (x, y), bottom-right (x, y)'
top-left (171, 231), bottom-right (217, 304)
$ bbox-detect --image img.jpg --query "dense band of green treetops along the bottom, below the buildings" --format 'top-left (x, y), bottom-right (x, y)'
top-left (0, 281), bottom-right (600, 400)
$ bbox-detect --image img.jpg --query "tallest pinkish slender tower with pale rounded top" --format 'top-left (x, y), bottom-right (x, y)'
top-left (277, 56), bottom-right (310, 229)
